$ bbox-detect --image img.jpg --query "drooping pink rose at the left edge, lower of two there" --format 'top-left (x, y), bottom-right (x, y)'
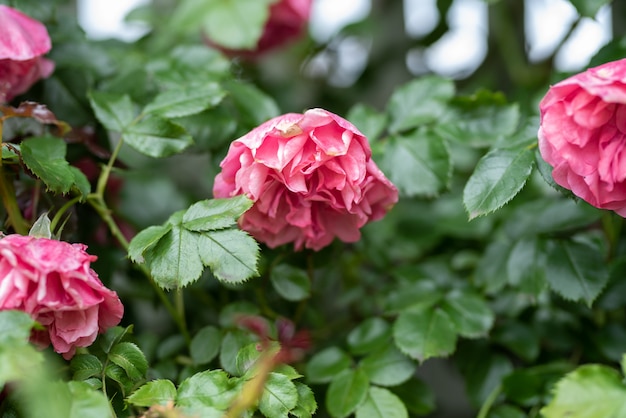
top-left (0, 234), bottom-right (124, 359)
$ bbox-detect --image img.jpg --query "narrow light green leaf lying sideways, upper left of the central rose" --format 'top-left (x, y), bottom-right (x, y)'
top-left (143, 83), bottom-right (226, 118)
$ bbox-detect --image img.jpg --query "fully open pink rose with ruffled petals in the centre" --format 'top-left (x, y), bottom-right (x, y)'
top-left (213, 109), bottom-right (398, 251)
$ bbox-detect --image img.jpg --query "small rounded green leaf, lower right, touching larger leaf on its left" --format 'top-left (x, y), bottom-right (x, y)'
top-left (441, 290), bottom-right (494, 338)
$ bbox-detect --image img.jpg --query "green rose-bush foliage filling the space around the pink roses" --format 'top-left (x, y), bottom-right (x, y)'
top-left (0, 0), bottom-right (626, 418)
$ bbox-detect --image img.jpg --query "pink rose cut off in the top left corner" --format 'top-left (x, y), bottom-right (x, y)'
top-left (0, 5), bottom-right (54, 104)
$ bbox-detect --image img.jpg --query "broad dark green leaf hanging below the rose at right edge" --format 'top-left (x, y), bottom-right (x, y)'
top-left (546, 241), bottom-right (609, 306)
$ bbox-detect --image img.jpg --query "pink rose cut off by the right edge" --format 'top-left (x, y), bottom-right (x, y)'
top-left (539, 59), bottom-right (626, 217)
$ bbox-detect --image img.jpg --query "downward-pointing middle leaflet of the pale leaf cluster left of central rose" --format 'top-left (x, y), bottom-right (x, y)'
top-left (144, 225), bottom-right (204, 289)
